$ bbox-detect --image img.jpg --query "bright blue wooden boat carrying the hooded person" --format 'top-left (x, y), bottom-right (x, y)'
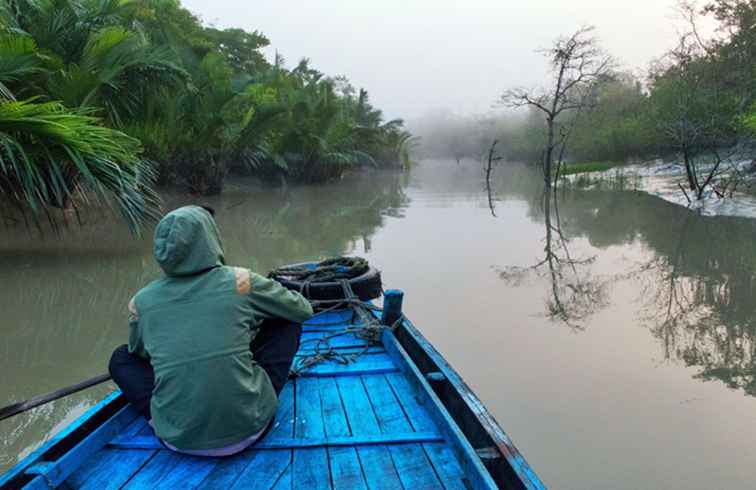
top-left (0, 300), bottom-right (545, 490)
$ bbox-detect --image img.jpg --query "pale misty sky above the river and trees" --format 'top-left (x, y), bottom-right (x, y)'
top-left (183, 0), bottom-right (696, 118)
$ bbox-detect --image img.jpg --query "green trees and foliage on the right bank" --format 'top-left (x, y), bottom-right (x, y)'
top-left (536, 0), bottom-right (756, 169)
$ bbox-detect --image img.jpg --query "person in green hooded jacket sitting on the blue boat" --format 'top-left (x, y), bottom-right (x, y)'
top-left (109, 206), bottom-right (313, 456)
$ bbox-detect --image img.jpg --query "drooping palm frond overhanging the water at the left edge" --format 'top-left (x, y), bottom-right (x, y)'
top-left (0, 99), bottom-right (159, 233)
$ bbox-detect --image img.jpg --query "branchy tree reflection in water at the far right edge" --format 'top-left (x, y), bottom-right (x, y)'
top-left (639, 214), bottom-right (756, 396)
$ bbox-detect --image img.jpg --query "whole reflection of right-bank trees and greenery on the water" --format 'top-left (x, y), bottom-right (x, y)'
top-left (546, 186), bottom-right (756, 395)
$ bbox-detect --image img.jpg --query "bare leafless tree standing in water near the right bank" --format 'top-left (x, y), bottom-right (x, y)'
top-left (500, 27), bottom-right (614, 187)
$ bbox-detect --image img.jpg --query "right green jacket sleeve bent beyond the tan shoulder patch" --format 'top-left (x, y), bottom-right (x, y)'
top-left (249, 273), bottom-right (313, 323)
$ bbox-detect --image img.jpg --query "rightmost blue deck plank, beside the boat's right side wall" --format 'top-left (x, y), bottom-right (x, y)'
top-left (386, 373), bottom-right (466, 490)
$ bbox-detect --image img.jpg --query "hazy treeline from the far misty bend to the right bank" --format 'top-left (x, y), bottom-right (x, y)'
top-left (412, 0), bottom-right (756, 168)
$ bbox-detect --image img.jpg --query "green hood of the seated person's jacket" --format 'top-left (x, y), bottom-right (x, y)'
top-left (154, 206), bottom-right (225, 276)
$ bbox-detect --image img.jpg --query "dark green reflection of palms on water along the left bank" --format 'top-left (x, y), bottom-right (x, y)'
top-left (0, 168), bottom-right (409, 471)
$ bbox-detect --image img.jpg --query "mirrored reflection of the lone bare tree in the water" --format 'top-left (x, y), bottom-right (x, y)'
top-left (498, 191), bottom-right (611, 331)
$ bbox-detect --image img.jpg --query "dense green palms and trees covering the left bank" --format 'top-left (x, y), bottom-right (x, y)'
top-left (0, 0), bottom-right (410, 229)
